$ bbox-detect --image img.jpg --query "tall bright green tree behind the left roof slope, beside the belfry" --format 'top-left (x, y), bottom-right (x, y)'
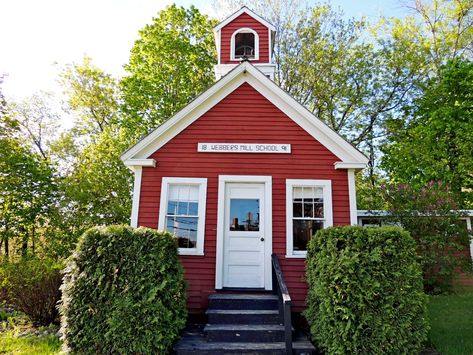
top-left (121, 5), bottom-right (216, 141)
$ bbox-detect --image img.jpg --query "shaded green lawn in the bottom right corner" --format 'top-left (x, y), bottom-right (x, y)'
top-left (429, 287), bottom-right (473, 355)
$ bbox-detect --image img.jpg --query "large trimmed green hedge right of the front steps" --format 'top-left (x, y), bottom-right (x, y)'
top-left (305, 226), bottom-right (428, 354)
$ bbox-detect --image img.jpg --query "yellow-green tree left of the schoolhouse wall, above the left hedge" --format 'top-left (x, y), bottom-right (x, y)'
top-left (63, 129), bottom-right (132, 228)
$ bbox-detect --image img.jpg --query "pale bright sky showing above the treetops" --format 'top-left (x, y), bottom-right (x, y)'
top-left (0, 0), bottom-right (406, 100)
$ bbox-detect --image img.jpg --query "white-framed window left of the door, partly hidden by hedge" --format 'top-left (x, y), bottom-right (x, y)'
top-left (158, 177), bottom-right (207, 255)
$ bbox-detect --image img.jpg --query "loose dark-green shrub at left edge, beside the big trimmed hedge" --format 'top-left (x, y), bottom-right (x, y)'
top-left (0, 258), bottom-right (63, 325)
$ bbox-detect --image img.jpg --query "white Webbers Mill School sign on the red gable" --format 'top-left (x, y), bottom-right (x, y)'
top-left (197, 143), bottom-right (291, 154)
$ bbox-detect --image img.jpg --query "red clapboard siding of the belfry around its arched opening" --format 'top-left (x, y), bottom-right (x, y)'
top-left (220, 13), bottom-right (270, 64)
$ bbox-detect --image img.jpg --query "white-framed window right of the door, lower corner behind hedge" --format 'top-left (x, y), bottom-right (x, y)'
top-left (286, 180), bottom-right (333, 257)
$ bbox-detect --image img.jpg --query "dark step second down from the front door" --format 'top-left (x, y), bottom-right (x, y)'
top-left (206, 309), bottom-right (281, 324)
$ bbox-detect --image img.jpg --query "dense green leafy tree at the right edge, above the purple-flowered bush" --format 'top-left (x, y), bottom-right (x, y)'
top-left (382, 60), bottom-right (473, 208)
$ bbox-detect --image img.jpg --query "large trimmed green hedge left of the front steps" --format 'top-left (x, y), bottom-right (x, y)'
top-left (60, 226), bottom-right (187, 354)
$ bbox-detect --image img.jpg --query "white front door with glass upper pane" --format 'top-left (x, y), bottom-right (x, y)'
top-left (223, 182), bottom-right (270, 288)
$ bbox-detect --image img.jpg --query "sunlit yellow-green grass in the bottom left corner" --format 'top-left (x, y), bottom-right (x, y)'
top-left (0, 331), bottom-right (61, 355)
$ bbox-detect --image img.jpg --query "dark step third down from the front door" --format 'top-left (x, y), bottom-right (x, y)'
top-left (204, 324), bottom-right (284, 343)
